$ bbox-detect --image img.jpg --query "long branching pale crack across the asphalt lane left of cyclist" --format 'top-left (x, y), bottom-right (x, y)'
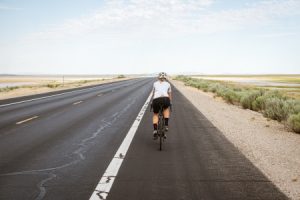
top-left (0, 98), bottom-right (136, 200)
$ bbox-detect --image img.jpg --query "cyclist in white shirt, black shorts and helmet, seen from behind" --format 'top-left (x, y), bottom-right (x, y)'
top-left (152, 72), bottom-right (172, 139)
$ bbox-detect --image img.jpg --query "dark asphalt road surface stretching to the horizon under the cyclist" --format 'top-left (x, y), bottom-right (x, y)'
top-left (0, 78), bottom-right (287, 200)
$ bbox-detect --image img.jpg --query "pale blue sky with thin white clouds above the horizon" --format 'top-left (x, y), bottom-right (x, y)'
top-left (0, 0), bottom-right (300, 74)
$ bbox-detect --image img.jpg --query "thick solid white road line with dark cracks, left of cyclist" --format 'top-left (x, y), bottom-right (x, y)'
top-left (90, 94), bottom-right (151, 200)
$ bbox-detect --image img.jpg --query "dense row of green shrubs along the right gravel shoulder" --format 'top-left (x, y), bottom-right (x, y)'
top-left (175, 76), bottom-right (300, 133)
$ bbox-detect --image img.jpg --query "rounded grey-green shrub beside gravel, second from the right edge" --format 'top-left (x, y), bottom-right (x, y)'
top-left (264, 97), bottom-right (289, 121)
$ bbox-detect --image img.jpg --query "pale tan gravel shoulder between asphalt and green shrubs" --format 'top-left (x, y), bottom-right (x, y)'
top-left (171, 80), bottom-right (300, 199)
